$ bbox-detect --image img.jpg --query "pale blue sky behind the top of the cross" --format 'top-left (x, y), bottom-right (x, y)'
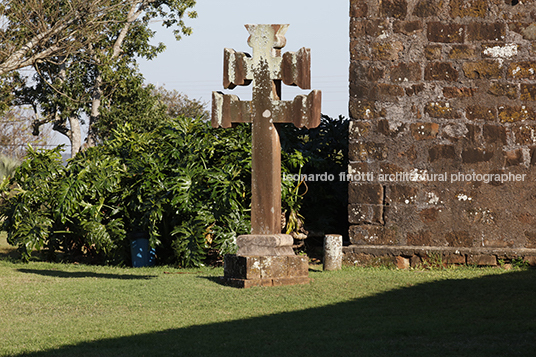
top-left (136, 0), bottom-right (349, 117)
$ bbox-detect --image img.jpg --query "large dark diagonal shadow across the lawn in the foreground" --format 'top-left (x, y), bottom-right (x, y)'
top-left (11, 270), bottom-right (536, 356)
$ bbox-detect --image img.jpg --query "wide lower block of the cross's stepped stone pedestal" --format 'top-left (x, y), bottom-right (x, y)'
top-left (223, 245), bottom-right (309, 288)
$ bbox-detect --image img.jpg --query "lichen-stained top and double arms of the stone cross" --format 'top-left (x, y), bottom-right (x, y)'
top-left (212, 25), bottom-right (322, 128)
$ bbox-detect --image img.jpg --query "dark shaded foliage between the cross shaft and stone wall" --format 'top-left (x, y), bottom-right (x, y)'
top-left (280, 115), bottom-right (349, 235)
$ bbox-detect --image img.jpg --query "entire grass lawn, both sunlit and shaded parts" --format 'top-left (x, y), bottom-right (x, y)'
top-left (0, 232), bottom-right (536, 356)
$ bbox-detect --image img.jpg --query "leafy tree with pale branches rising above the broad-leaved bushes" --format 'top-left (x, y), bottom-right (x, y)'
top-left (4, 0), bottom-right (196, 154)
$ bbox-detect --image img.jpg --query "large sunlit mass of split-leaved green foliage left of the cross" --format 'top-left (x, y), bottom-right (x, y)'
top-left (0, 117), bottom-right (251, 266)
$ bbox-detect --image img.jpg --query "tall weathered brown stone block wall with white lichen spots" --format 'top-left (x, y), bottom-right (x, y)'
top-left (348, 0), bottom-right (536, 254)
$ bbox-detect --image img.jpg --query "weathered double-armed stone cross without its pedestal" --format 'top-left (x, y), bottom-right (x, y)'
top-left (212, 25), bottom-right (322, 235)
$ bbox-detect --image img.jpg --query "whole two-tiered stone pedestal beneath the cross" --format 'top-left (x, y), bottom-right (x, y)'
top-left (223, 234), bottom-right (309, 288)
